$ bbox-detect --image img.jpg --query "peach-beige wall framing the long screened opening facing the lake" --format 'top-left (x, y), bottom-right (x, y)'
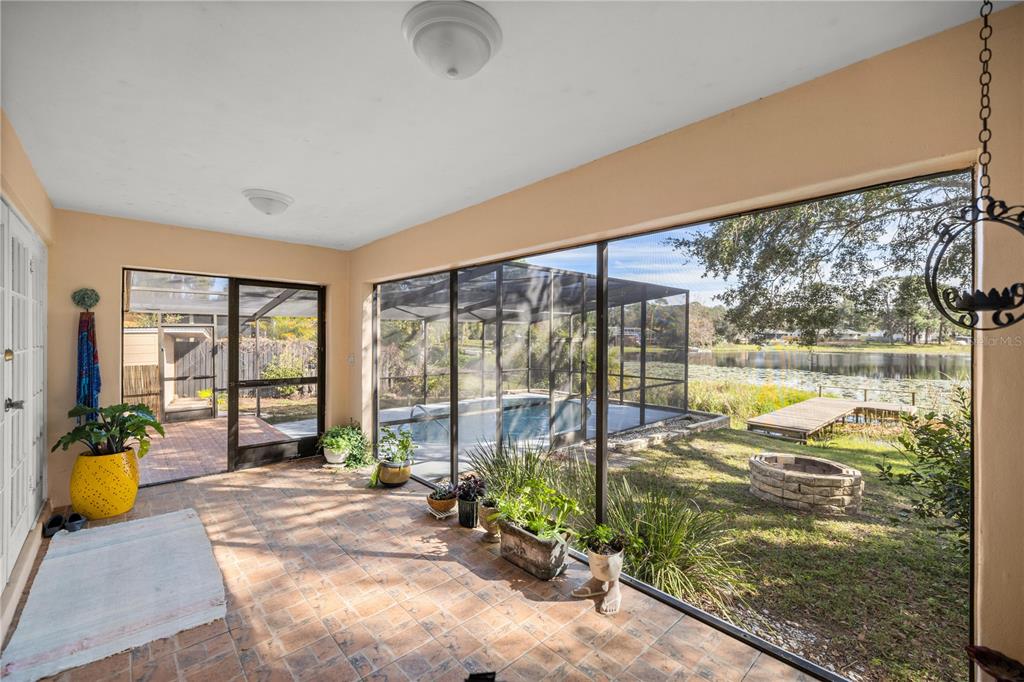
top-left (349, 6), bottom-right (1024, 658)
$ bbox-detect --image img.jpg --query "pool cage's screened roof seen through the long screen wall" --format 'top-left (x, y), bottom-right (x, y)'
top-left (379, 263), bottom-right (689, 322)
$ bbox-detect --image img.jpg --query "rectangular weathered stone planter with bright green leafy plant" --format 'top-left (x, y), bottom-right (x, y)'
top-left (498, 479), bottom-right (580, 581)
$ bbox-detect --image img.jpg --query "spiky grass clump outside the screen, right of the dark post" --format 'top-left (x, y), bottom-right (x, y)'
top-left (608, 479), bottom-right (745, 613)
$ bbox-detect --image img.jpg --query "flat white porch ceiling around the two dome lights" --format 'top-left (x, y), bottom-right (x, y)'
top-left (0, 1), bottom-right (977, 249)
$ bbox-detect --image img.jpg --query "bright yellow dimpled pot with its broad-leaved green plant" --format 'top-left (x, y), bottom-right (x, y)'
top-left (50, 404), bottom-right (164, 519)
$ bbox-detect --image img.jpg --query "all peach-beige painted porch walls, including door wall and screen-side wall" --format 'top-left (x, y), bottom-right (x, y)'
top-left (2, 6), bottom-right (1024, 658)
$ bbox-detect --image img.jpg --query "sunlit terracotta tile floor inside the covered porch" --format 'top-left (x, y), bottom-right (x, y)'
top-left (22, 461), bottom-right (809, 682)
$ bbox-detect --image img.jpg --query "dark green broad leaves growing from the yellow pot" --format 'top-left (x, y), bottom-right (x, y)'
top-left (50, 404), bottom-right (164, 458)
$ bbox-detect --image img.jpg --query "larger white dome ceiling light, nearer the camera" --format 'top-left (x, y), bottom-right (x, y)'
top-left (401, 0), bottom-right (502, 80)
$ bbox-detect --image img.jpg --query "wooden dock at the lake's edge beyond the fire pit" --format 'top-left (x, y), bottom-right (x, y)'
top-left (746, 397), bottom-right (916, 442)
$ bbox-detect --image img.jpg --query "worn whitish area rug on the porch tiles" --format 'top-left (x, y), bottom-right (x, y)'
top-left (2, 509), bottom-right (225, 682)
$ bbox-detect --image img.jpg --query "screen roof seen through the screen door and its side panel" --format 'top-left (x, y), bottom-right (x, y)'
top-left (124, 270), bottom-right (316, 323)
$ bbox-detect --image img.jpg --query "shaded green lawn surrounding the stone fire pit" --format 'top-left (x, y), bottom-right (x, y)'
top-left (630, 429), bottom-right (969, 680)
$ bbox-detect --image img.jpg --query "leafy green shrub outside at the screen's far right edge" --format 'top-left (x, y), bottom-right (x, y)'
top-left (877, 386), bottom-right (972, 554)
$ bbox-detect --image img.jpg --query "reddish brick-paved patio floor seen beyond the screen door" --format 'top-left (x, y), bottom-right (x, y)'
top-left (138, 415), bottom-right (288, 485)
